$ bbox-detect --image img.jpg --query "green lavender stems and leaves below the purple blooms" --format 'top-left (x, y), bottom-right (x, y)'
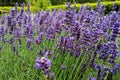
top-left (0, 30), bottom-right (120, 80)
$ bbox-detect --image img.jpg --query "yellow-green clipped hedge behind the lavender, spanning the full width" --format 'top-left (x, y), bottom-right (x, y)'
top-left (0, 1), bottom-right (120, 14)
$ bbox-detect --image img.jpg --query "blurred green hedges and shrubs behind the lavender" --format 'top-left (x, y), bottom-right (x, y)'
top-left (0, 0), bottom-right (120, 14)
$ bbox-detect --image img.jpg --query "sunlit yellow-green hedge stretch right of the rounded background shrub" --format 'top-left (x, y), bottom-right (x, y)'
top-left (48, 1), bottom-right (120, 14)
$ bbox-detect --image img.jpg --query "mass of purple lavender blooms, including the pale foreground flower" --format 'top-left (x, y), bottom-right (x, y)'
top-left (0, 0), bottom-right (120, 80)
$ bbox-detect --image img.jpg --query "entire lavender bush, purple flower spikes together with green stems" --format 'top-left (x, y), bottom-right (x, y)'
top-left (0, 1), bottom-right (120, 80)
